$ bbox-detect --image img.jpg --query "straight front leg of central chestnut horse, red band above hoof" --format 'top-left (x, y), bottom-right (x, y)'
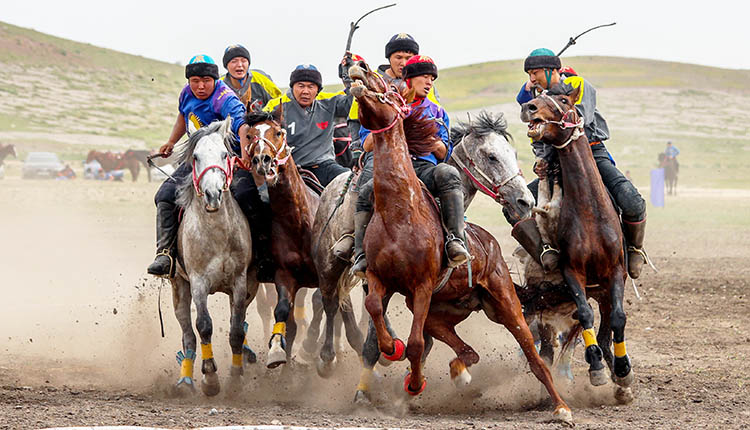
top-left (404, 282), bottom-right (433, 396)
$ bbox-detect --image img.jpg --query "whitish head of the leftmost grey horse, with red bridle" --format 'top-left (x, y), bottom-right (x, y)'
top-left (178, 117), bottom-right (234, 212)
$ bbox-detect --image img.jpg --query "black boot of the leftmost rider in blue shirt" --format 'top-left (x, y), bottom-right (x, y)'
top-left (146, 202), bottom-right (179, 278)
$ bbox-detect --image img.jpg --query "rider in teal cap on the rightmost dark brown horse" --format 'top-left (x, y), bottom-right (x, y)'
top-left (511, 48), bottom-right (647, 279)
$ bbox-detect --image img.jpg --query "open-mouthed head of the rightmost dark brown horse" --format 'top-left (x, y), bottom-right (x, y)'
top-left (521, 88), bottom-right (583, 145)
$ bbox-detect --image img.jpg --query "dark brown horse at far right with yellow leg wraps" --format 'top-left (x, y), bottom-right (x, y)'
top-left (521, 89), bottom-right (634, 387)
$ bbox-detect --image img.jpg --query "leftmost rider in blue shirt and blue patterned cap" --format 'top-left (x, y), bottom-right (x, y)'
top-left (148, 55), bottom-right (274, 282)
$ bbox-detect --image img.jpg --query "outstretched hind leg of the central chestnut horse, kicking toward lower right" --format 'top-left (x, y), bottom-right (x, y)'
top-left (483, 271), bottom-right (573, 423)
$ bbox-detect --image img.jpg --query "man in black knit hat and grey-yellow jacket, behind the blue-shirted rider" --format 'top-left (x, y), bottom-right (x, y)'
top-left (221, 45), bottom-right (281, 112)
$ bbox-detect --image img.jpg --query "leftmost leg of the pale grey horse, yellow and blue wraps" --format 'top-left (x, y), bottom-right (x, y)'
top-left (172, 277), bottom-right (196, 393)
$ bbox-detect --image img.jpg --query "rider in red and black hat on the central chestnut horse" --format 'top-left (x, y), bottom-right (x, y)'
top-left (352, 55), bottom-right (469, 278)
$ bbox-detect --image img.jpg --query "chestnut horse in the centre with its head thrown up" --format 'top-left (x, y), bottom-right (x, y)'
top-left (349, 65), bottom-right (572, 421)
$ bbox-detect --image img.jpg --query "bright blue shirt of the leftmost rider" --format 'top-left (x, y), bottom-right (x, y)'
top-left (179, 80), bottom-right (245, 154)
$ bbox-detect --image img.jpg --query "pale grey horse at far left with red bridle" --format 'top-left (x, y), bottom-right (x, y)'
top-left (170, 118), bottom-right (258, 396)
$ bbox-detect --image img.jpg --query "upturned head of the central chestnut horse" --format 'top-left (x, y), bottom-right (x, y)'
top-left (349, 62), bottom-right (413, 133)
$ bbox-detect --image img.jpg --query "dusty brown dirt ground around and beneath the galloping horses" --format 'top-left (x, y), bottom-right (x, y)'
top-left (0, 178), bottom-right (750, 429)
